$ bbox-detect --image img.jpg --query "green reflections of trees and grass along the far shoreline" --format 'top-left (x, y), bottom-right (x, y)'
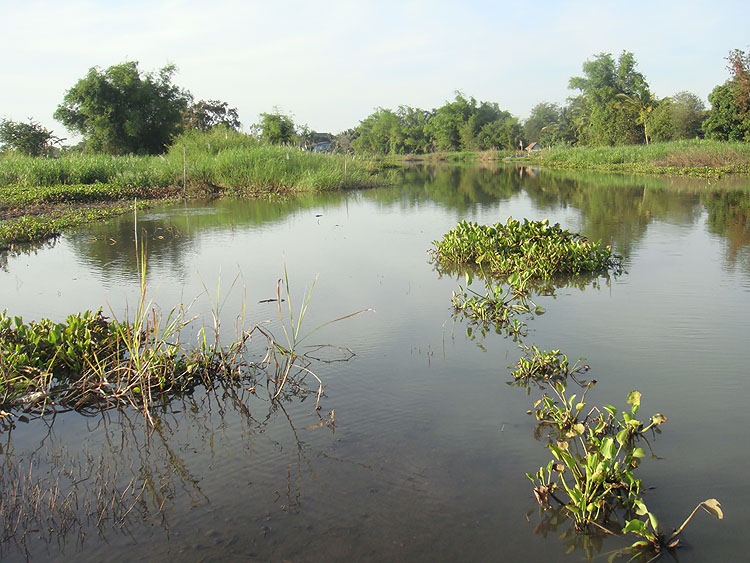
top-left (36, 166), bottom-right (750, 281)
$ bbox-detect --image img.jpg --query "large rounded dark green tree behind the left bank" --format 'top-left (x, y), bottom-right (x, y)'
top-left (55, 61), bottom-right (190, 154)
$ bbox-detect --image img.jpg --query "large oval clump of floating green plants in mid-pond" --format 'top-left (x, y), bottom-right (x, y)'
top-left (433, 217), bottom-right (620, 279)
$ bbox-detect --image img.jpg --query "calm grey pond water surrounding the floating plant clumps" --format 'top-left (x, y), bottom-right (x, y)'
top-left (0, 166), bottom-right (750, 561)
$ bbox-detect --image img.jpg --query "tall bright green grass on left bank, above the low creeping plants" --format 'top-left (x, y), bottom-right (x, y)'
top-left (0, 129), bottom-right (384, 191)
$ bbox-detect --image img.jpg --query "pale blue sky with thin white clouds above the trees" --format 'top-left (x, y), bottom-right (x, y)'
top-left (0, 0), bottom-right (750, 139)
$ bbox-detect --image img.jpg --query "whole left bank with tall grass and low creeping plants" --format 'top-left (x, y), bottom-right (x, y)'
top-left (0, 130), bottom-right (385, 249)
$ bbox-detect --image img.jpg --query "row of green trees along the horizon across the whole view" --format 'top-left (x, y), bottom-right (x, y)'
top-left (0, 49), bottom-right (750, 156)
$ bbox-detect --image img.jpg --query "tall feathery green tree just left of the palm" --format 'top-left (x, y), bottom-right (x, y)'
top-left (569, 51), bottom-right (652, 145)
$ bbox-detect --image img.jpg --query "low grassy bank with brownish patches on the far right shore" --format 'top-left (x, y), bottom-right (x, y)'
top-left (530, 140), bottom-right (750, 178)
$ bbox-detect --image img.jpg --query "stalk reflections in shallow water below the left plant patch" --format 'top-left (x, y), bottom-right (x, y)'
top-left (0, 376), bottom-right (335, 559)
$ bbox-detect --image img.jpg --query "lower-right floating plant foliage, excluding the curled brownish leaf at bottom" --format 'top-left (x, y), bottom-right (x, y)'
top-left (514, 348), bottom-right (666, 531)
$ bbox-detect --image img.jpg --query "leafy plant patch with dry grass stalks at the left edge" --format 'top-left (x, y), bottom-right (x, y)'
top-left (0, 268), bottom-right (364, 430)
